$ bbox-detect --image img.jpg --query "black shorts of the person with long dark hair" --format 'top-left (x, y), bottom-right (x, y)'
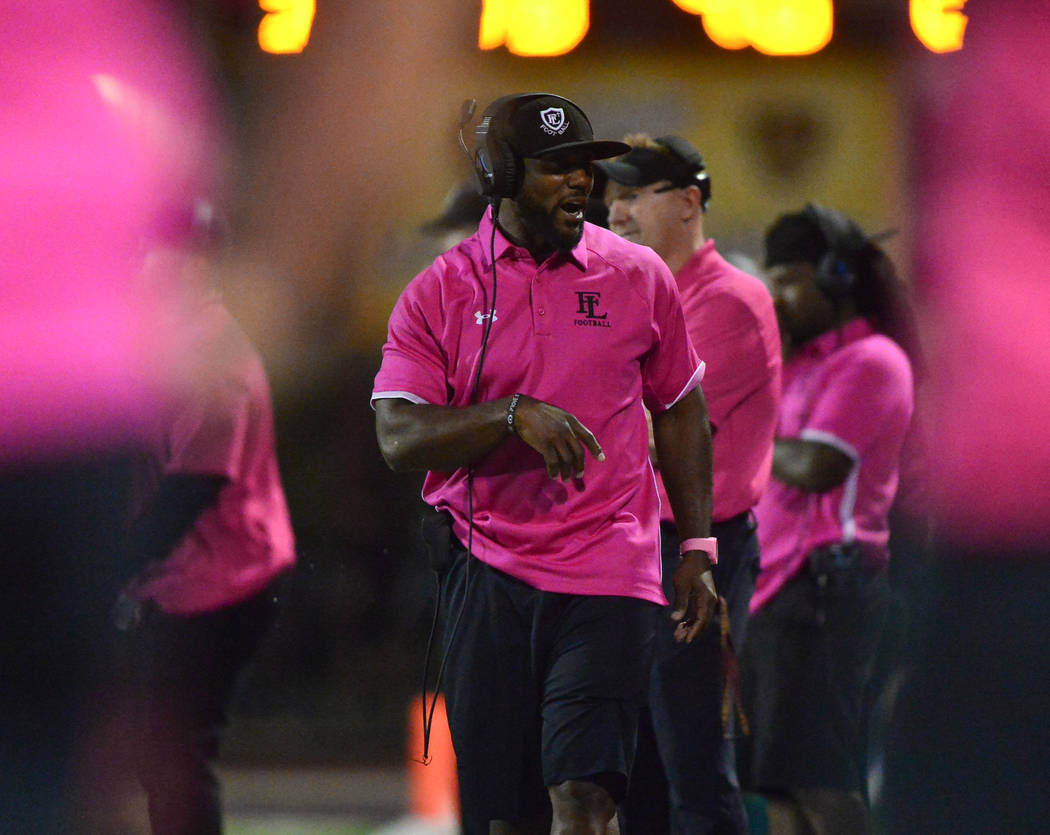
top-left (740, 549), bottom-right (888, 791)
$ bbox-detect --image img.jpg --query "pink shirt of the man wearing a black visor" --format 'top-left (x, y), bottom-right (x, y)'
top-left (657, 241), bottom-right (780, 522)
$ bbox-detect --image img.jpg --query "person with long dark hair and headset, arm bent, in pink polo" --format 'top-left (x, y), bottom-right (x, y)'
top-left (741, 204), bottom-right (915, 835)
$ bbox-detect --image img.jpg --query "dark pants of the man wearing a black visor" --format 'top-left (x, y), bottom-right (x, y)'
top-left (621, 514), bottom-right (758, 835)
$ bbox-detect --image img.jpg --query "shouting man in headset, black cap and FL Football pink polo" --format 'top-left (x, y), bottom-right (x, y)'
top-left (373, 93), bottom-right (717, 835)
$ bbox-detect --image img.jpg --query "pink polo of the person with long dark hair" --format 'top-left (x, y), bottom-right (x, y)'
top-left (751, 318), bottom-right (915, 611)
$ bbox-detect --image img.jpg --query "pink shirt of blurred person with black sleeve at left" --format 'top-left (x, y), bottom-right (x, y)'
top-left (130, 297), bottom-right (295, 614)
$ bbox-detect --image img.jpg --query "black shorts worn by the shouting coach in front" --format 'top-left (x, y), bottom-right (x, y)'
top-left (442, 549), bottom-right (659, 833)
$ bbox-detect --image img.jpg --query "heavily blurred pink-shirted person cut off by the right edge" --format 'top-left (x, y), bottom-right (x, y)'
top-left (880, 0), bottom-right (1050, 835)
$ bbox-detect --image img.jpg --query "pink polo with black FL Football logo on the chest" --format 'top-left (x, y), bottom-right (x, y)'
top-left (372, 205), bottom-right (704, 605)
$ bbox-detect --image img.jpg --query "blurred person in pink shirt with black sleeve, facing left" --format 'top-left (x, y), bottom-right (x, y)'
top-left (114, 201), bottom-right (295, 835)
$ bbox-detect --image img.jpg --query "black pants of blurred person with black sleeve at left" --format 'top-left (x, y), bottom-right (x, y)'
top-left (129, 586), bottom-right (276, 835)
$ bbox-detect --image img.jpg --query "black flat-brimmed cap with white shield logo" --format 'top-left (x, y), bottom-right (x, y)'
top-left (507, 93), bottom-right (631, 160)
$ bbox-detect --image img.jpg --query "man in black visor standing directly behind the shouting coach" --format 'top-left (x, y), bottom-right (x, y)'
top-left (599, 134), bottom-right (780, 835)
